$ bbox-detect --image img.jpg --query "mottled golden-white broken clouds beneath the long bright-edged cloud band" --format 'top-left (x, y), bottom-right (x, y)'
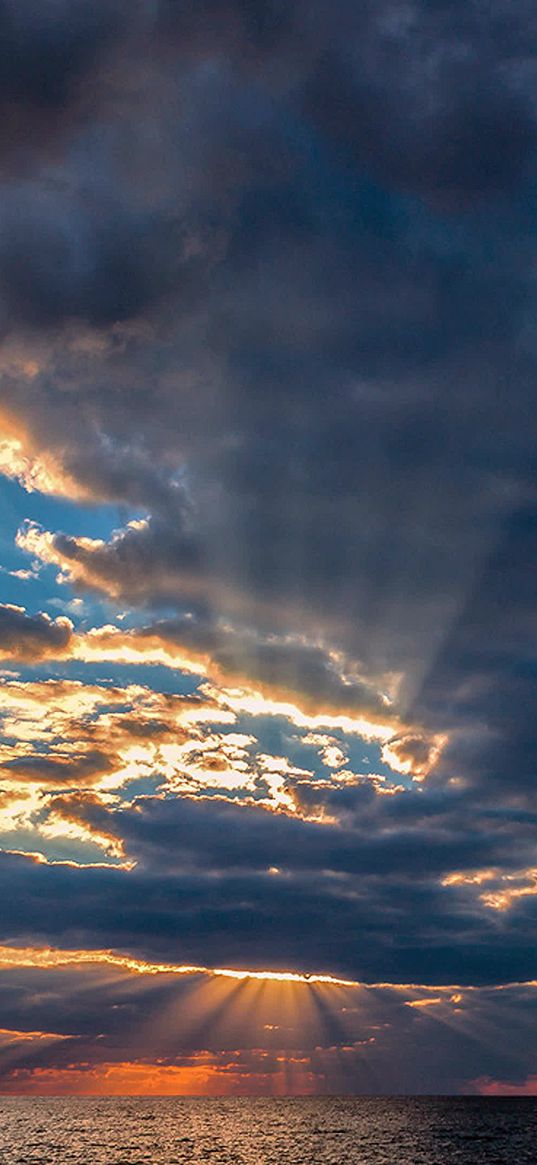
top-left (0, 657), bottom-right (424, 857)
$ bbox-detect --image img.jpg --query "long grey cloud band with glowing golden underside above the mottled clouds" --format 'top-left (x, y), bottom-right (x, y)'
top-left (0, 601), bottom-right (412, 736)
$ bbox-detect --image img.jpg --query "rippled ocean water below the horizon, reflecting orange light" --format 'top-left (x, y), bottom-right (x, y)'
top-left (0, 1097), bottom-right (537, 1165)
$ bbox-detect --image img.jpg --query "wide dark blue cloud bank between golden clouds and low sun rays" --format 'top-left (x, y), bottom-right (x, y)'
top-left (1, 795), bottom-right (535, 983)
